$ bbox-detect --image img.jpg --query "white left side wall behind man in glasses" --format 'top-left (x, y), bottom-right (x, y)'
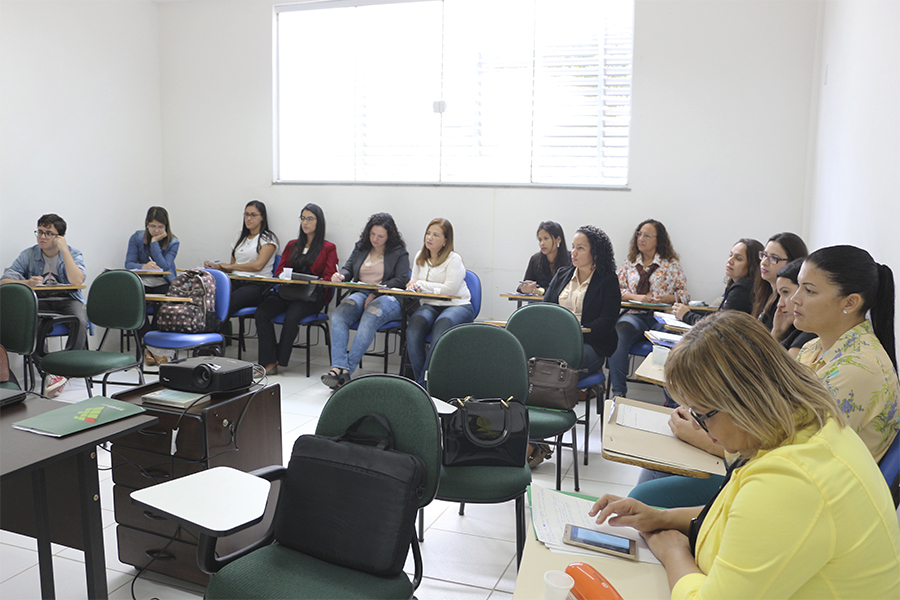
top-left (0, 1), bottom-right (162, 278)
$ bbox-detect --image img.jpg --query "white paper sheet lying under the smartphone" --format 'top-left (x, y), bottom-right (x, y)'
top-left (531, 485), bottom-right (662, 565)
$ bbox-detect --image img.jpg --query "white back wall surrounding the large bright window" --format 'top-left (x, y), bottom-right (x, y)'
top-left (160, 0), bottom-right (820, 317)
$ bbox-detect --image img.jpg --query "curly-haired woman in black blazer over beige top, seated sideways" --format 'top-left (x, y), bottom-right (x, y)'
top-left (544, 225), bottom-right (622, 373)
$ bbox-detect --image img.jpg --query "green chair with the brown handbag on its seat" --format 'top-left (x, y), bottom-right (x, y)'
top-left (506, 304), bottom-right (588, 492)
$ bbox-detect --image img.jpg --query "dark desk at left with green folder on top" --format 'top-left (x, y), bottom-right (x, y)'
top-left (0, 395), bottom-right (158, 598)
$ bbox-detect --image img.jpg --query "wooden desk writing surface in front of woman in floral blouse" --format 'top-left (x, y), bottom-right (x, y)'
top-left (602, 397), bottom-right (725, 479)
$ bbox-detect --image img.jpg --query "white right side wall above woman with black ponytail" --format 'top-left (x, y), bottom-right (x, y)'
top-left (809, 0), bottom-right (900, 277)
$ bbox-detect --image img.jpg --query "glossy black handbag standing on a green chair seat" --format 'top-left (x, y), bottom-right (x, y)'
top-left (441, 397), bottom-right (528, 467)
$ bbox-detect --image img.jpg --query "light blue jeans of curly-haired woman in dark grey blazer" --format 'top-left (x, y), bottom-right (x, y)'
top-left (331, 292), bottom-right (400, 375)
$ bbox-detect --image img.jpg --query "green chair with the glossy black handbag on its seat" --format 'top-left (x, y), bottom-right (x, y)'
top-left (419, 323), bottom-right (531, 564)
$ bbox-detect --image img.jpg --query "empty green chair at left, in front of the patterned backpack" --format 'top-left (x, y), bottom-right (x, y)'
top-left (39, 270), bottom-right (146, 396)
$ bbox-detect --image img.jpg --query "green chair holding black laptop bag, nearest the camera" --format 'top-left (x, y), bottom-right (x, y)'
top-left (198, 374), bottom-right (441, 600)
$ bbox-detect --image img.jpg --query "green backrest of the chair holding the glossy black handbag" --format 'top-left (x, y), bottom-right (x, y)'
top-left (426, 323), bottom-right (528, 402)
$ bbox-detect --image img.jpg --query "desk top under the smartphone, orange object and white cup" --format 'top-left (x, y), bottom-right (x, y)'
top-left (513, 522), bottom-right (671, 600)
